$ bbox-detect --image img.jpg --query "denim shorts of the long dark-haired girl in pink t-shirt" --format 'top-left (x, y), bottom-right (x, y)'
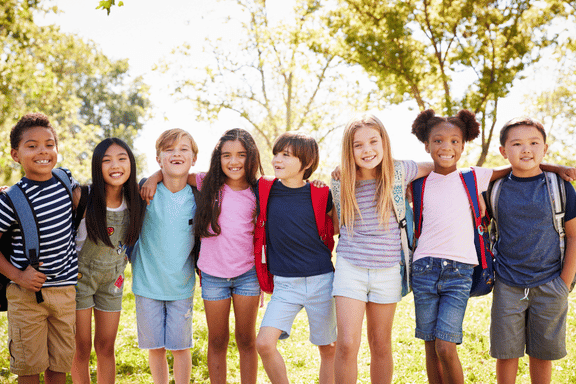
top-left (201, 267), bottom-right (260, 301)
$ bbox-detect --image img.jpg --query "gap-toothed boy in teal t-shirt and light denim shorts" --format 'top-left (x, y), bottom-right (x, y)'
top-left (132, 129), bottom-right (198, 383)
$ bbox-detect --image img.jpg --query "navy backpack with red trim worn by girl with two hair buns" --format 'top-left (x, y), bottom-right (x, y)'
top-left (412, 168), bottom-right (494, 297)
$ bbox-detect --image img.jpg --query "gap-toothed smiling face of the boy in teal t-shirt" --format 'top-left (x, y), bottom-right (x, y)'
top-left (156, 137), bottom-right (196, 179)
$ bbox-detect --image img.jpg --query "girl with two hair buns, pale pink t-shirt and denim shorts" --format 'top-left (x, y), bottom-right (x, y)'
top-left (412, 109), bottom-right (509, 383)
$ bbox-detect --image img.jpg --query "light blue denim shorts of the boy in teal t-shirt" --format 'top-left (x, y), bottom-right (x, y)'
top-left (135, 295), bottom-right (194, 351)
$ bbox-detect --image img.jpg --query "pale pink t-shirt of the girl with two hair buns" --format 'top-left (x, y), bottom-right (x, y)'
top-left (414, 167), bottom-right (492, 265)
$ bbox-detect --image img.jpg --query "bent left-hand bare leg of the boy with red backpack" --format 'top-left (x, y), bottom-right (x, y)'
top-left (256, 327), bottom-right (289, 384)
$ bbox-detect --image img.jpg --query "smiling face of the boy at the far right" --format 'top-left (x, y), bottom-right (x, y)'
top-left (500, 125), bottom-right (548, 177)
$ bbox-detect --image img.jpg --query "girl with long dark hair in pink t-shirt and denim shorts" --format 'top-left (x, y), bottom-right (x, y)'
top-left (194, 128), bottom-right (262, 383)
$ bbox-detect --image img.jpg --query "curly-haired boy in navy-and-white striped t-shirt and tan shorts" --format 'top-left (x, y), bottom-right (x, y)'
top-left (0, 113), bottom-right (79, 384)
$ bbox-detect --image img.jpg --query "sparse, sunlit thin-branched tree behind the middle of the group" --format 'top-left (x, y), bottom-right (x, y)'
top-left (160, 0), bottom-right (376, 172)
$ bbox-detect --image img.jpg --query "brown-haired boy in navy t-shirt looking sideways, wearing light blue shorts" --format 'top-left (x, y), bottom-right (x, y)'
top-left (256, 133), bottom-right (338, 384)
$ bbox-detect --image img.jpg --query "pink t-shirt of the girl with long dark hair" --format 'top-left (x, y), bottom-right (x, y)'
top-left (196, 173), bottom-right (256, 278)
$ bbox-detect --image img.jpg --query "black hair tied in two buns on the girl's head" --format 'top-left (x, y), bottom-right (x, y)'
top-left (412, 109), bottom-right (480, 143)
